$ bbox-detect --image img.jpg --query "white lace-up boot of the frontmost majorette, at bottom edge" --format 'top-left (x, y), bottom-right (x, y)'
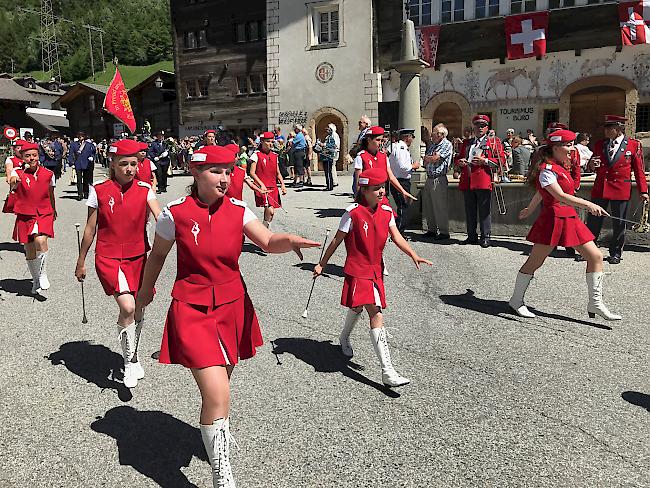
top-left (201, 419), bottom-right (235, 488)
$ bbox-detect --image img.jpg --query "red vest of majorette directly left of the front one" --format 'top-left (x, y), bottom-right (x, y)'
top-left (93, 180), bottom-right (151, 259)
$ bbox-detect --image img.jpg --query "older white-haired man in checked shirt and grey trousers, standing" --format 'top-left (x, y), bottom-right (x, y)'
top-left (422, 124), bottom-right (454, 241)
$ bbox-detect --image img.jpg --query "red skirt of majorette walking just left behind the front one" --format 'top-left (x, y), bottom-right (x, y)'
top-left (95, 254), bottom-right (147, 295)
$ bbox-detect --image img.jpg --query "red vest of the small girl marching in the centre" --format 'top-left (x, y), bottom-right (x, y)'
top-left (343, 203), bottom-right (393, 279)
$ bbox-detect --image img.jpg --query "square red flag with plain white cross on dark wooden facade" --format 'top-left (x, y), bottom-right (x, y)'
top-left (505, 11), bottom-right (549, 59)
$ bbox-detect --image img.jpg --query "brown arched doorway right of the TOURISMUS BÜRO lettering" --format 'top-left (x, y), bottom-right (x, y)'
top-left (569, 86), bottom-right (625, 139)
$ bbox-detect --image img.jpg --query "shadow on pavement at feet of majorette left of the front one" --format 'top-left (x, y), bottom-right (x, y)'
top-left (45, 341), bottom-right (133, 402)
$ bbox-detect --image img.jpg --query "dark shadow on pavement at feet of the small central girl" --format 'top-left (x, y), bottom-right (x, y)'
top-left (271, 337), bottom-right (400, 398)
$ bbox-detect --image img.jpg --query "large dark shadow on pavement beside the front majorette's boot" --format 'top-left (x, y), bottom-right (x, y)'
top-left (90, 405), bottom-right (206, 488)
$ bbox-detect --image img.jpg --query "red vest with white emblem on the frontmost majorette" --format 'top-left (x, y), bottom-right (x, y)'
top-left (168, 195), bottom-right (246, 307)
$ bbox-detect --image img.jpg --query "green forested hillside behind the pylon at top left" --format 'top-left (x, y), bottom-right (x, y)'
top-left (0, 0), bottom-right (172, 82)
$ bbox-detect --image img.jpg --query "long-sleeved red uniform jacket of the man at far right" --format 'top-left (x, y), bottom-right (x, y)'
top-left (591, 136), bottom-right (648, 200)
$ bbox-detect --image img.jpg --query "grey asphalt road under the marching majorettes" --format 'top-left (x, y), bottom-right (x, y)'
top-left (0, 172), bottom-right (650, 488)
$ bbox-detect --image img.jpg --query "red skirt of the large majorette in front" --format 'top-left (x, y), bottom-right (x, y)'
top-left (159, 293), bottom-right (264, 368)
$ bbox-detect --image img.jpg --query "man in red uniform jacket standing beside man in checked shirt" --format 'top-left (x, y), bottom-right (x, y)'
top-left (455, 114), bottom-right (506, 247)
